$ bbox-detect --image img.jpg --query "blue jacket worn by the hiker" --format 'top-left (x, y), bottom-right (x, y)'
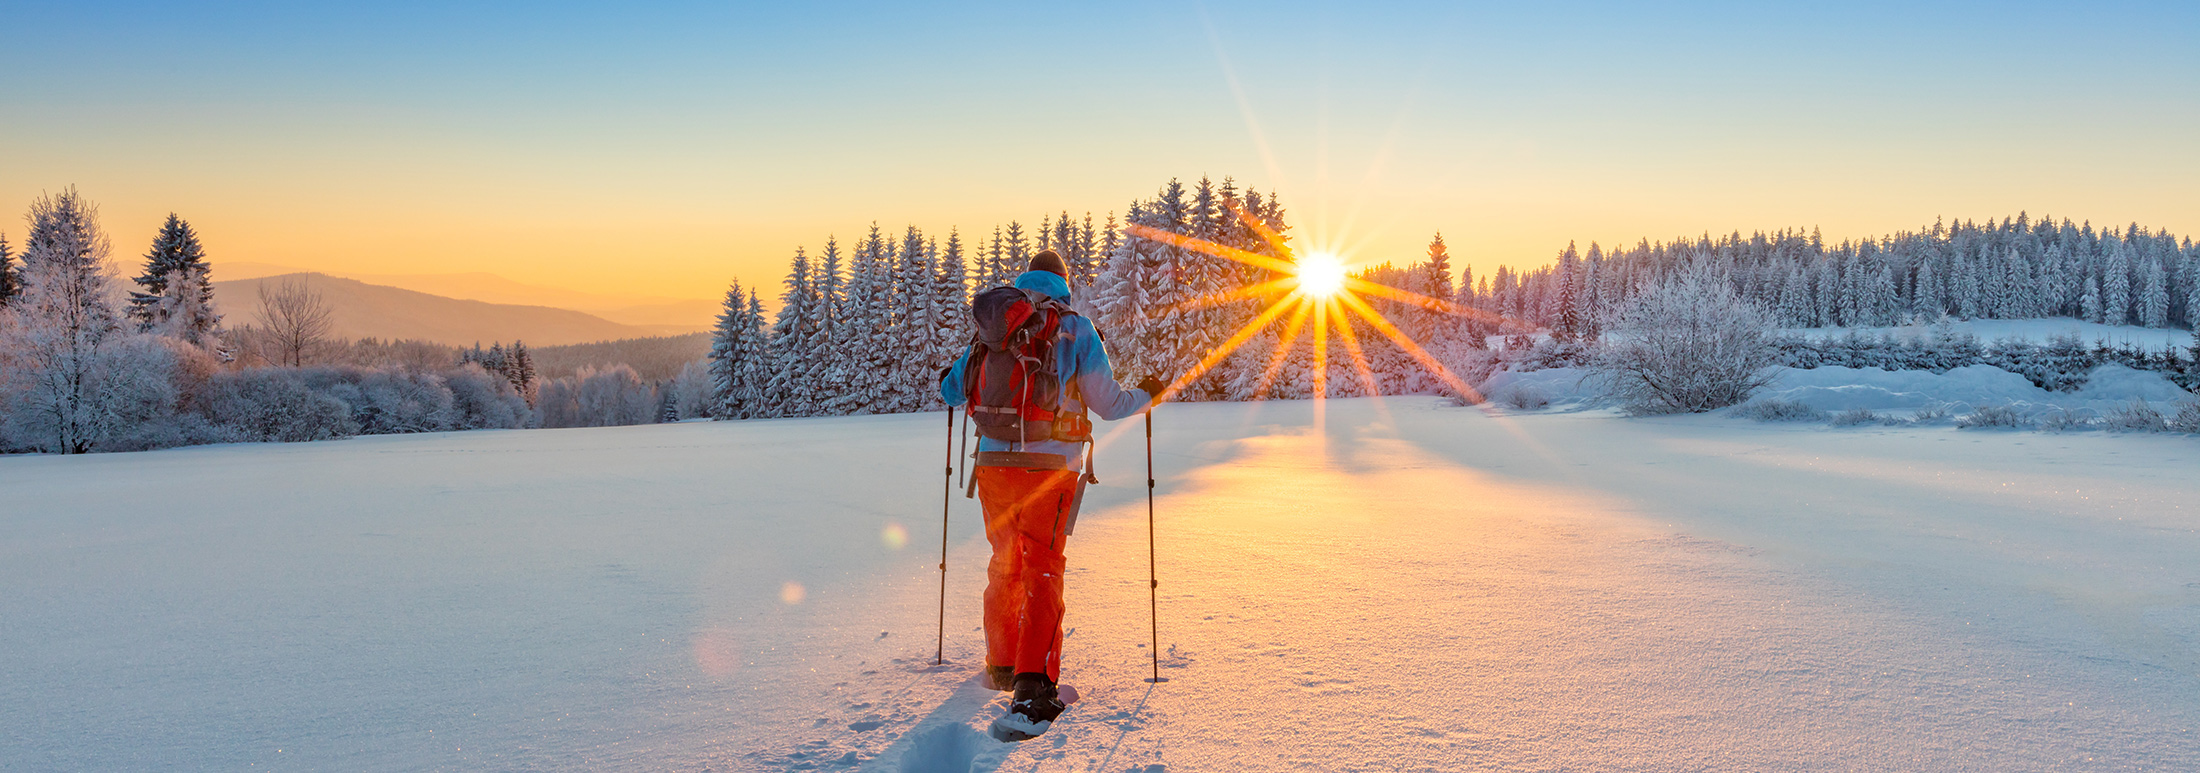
top-left (939, 271), bottom-right (1153, 469)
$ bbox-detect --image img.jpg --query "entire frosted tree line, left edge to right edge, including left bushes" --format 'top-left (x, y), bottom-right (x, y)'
top-left (0, 178), bottom-right (2200, 454)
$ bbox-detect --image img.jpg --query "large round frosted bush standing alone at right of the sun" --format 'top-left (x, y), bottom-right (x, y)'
top-left (1595, 269), bottom-right (1775, 414)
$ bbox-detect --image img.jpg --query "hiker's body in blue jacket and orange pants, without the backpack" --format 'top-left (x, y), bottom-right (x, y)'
top-left (939, 251), bottom-right (1164, 740)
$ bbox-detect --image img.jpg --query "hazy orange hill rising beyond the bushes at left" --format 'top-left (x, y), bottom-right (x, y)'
top-left (213, 266), bottom-right (704, 346)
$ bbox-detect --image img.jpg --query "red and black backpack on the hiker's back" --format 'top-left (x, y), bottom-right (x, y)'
top-left (964, 286), bottom-right (1093, 443)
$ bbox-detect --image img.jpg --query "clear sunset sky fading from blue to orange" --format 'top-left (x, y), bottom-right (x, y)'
top-left (0, 0), bottom-right (2200, 297)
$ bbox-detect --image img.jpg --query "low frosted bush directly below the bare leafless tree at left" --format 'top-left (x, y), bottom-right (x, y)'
top-left (200, 368), bottom-right (359, 443)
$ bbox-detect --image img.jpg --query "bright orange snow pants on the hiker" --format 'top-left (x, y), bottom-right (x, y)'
top-left (977, 467), bottom-right (1078, 681)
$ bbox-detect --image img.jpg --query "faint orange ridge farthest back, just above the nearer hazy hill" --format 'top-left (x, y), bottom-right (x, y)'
top-left (213, 262), bottom-right (719, 333)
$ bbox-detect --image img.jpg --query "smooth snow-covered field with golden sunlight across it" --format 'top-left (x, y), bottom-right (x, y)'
top-left (0, 399), bottom-right (2200, 773)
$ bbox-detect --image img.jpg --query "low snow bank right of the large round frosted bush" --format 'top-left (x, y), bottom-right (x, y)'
top-left (1758, 366), bottom-right (2193, 416)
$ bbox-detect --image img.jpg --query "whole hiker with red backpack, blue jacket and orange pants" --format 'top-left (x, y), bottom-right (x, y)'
top-left (939, 249), bottom-right (1164, 740)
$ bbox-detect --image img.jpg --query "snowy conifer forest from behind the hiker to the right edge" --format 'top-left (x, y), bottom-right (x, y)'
top-left (711, 178), bottom-right (2200, 418)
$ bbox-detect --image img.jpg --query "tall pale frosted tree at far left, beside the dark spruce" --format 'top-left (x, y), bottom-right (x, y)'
top-left (0, 187), bottom-right (121, 454)
